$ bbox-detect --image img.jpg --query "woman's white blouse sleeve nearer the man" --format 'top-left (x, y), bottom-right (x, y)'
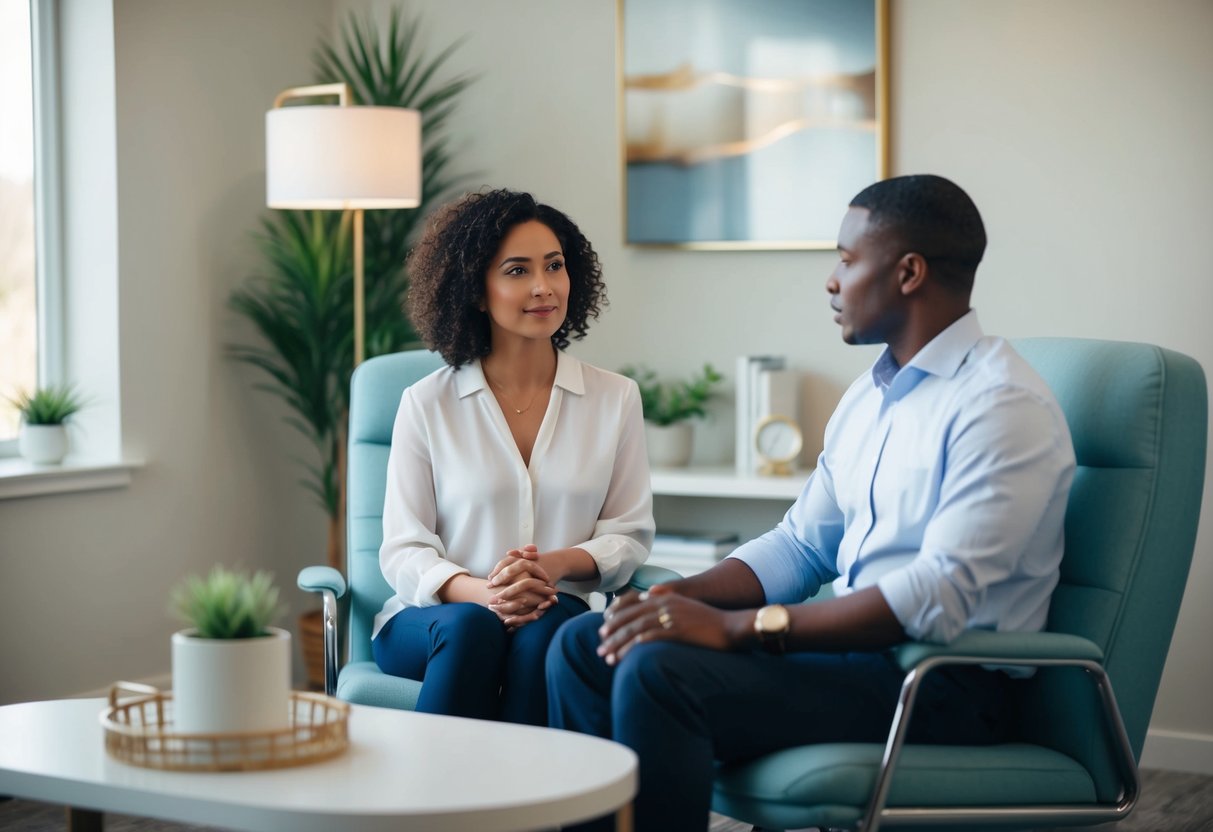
top-left (568, 383), bottom-right (656, 592)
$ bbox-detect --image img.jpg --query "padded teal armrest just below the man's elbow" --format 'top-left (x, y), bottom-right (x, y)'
top-left (894, 629), bottom-right (1104, 671)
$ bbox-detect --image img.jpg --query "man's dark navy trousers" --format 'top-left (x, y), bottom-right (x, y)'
top-left (547, 614), bottom-right (1013, 832)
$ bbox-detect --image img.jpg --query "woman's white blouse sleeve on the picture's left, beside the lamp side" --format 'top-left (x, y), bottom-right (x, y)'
top-left (380, 388), bottom-right (468, 606)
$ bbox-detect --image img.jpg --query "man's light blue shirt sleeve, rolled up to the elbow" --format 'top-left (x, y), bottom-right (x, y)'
top-left (877, 386), bottom-right (1074, 644)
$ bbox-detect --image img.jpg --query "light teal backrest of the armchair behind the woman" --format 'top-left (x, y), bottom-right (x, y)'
top-left (346, 349), bottom-right (443, 661)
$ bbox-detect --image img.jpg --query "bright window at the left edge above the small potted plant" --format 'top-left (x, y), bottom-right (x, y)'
top-left (0, 0), bottom-right (59, 456)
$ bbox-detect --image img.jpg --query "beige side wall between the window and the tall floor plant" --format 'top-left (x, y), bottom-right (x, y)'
top-left (0, 0), bottom-right (331, 702)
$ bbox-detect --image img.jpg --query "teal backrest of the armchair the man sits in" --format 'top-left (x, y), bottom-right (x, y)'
top-left (1015, 338), bottom-right (1208, 799)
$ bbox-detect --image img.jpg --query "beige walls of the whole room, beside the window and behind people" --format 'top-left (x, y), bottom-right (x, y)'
top-left (0, 0), bottom-right (1213, 771)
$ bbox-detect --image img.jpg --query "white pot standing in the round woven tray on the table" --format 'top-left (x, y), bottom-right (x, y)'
top-left (172, 627), bottom-right (291, 734)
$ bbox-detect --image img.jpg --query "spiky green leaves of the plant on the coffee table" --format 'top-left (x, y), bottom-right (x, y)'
top-left (171, 565), bottom-right (285, 639)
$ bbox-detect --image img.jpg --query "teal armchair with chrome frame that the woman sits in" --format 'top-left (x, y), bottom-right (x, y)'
top-left (298, 349), bottom-right (677, 711)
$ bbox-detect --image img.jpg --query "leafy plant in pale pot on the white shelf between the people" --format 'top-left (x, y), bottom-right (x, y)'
top-left (620, 364), bottom-right (723, 467)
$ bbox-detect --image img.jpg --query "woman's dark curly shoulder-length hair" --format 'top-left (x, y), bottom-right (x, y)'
top-left (406, 189), bottom-right (607, 369)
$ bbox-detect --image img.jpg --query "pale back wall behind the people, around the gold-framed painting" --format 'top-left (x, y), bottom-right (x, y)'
top-left (351, 0), bottom-right (1213, 771)
